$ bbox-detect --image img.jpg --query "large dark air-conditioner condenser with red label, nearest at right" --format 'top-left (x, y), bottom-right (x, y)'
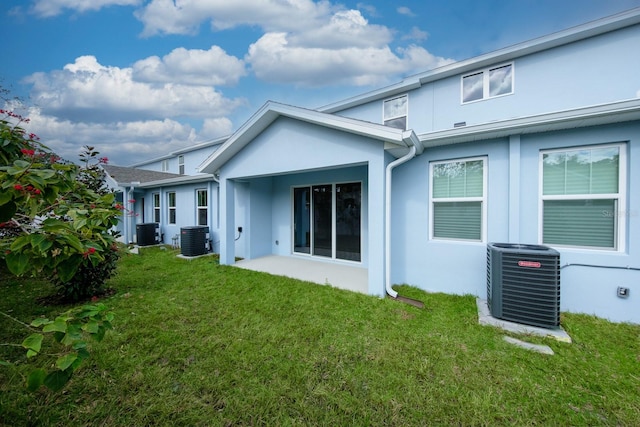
top-left (487, 243), bottom-right (560, 329)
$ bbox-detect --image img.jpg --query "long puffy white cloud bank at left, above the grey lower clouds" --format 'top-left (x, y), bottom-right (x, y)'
top-left (25, 56), bottom-right (243, 123)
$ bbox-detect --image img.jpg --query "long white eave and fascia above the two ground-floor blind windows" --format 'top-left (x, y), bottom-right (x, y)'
top-left (418, 98), bottom-right (640, 148)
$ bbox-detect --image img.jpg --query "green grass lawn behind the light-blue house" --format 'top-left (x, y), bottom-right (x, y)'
top-left (0, 248), bottom-right (640, 426)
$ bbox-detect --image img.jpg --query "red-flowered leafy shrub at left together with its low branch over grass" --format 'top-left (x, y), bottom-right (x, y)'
top-left (0, 106), bottom-right (120, 390)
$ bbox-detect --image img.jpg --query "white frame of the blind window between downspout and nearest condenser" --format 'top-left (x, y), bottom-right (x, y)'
top-left (429, 156), bottom-right (489, 243)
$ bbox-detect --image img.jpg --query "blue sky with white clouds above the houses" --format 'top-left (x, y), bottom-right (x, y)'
top-left (0, 0), bottom-right (640, 166)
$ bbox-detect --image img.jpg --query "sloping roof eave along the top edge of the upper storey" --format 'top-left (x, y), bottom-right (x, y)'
top-left (318, 8), bottom-right (640, 113)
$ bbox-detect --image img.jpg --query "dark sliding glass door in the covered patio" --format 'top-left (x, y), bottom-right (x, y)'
top-left (293, 182), bottom-right (362, 261)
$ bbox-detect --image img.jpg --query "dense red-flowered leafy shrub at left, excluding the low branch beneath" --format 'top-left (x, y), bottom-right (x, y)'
top-left (0, 110), bottom-right (121, 301)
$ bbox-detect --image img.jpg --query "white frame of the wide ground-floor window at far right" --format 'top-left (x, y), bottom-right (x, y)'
top-left (538, 142), bottom-right (629, 252)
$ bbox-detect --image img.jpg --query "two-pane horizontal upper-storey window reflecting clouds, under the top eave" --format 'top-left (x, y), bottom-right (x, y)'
top-left (462, 63), bottom-right (514, 104)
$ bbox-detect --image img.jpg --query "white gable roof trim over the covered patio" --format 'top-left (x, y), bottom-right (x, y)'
top-left (198, 101), bottom-right (419, 173)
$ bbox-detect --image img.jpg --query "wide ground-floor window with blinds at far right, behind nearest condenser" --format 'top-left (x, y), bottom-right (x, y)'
top-left (541, 144), bottom-right (625, 250)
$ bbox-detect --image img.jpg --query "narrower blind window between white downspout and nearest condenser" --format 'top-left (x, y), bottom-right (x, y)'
top-left (430, 158), bottom-right (486, 241)
